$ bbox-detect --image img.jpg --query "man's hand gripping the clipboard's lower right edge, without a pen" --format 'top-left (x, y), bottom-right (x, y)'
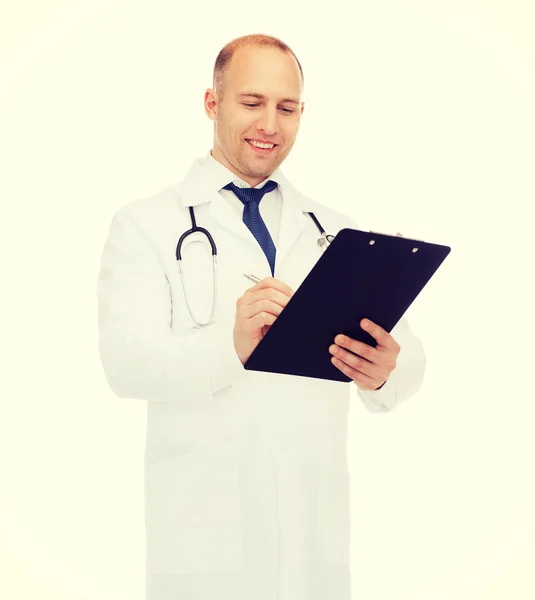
top-left (329, 319), bottom-right (400, 390)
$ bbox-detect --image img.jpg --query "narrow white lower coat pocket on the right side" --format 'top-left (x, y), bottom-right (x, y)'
top-left (318, 466), bottom-right (351, 565)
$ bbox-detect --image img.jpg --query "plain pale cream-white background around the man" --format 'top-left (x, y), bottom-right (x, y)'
top-left (0, 0), bottom-right (535, 600)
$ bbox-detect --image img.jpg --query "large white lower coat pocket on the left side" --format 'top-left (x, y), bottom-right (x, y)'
top-left (145, 453), bottom-right (243, 574)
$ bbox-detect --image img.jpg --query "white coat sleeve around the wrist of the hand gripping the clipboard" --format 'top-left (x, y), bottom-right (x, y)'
top-left (348, 213), bottom-right (426, 413)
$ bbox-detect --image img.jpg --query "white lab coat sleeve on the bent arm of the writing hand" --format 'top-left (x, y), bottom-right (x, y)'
top-left (97, 207), bottom-right (246, 401)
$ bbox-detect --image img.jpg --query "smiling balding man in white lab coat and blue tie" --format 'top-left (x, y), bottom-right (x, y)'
top-left (98, 36), bottom-right (425, 600)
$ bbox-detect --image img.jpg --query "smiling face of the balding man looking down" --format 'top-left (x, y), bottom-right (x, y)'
top-left (205, 46), bottom-right (304, 187)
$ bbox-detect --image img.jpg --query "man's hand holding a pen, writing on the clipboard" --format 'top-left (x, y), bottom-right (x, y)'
top-left (234, 277), bottom-right (294, 365)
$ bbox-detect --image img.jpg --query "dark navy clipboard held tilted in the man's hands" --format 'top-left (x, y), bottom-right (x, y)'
top-left (244, 228), bottom-right (451, 382)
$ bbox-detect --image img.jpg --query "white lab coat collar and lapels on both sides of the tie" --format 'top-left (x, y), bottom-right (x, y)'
top-left (180, 152), bottom-right (315, 271)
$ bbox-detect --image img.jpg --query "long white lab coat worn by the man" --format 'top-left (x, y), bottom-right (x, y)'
top-left (97, 161), bottom-right (425, 600)
